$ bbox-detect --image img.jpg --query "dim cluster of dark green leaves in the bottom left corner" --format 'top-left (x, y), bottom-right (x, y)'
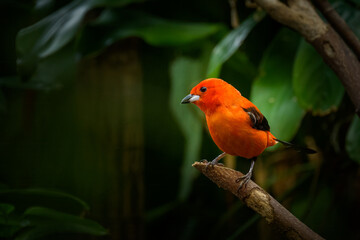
top-left (0, 189), bottom-right (107, 240)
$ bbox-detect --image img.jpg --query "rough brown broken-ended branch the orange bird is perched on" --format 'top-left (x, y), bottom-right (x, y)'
top-left (193, 162), bottom-right (323, 240)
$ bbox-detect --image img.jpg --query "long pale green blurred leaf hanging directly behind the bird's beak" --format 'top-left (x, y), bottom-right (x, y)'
top-left (170, 57), bottom-right (202, 201)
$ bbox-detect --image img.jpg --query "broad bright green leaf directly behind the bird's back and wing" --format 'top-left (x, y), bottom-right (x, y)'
top-left (251, 29), bottom-right (304, 141)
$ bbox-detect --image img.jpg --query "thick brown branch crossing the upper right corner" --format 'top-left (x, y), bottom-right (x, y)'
top-left (254, 0), bottom-right (360, 117)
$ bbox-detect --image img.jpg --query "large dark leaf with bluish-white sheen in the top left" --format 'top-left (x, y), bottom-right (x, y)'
top-left (16, 0), bottom-right (141, 77)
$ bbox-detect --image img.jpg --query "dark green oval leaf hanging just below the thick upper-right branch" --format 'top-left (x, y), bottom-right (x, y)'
top-left (293, 40), bottom-right (344, 115)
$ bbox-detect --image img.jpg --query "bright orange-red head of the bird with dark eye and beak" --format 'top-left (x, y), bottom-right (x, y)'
top-left (181, 78), bottom-right (241, 113)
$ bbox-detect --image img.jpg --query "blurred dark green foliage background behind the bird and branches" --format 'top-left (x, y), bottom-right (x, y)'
top-left (0, 0), bottom-right (360, 239)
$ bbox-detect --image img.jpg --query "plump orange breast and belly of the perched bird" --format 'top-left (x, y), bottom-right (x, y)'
top-left (206, 105), bottom-right (276, 159)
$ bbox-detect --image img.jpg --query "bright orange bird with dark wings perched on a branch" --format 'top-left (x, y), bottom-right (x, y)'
top-left (181, 78), bottom-right (315, 189)
